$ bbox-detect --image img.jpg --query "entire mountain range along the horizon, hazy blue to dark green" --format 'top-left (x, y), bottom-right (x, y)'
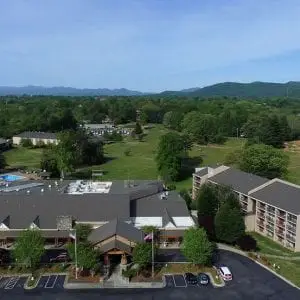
top-left (0, 81), bottom-right (300, 98)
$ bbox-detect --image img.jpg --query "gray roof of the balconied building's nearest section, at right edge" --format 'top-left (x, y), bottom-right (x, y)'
top-left (250, 181), bottom-right (300, 215)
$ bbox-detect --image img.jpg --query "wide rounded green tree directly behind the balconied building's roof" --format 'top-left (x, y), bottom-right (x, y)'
top-left (238, 144), bottom-right (289, 179)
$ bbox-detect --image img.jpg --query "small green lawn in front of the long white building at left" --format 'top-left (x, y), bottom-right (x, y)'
top-left (4, 147), bottom-right (43, 168)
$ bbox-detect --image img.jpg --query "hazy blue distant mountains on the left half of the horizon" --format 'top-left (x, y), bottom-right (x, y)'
top-left (0, 85), bottom-right (144, 96)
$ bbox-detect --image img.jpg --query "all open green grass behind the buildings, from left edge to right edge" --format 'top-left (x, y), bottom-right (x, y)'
top-left (4, 125), bottom-right (300, 189)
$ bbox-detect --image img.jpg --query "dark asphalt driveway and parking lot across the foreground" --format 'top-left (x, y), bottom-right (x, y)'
top-left (0, 251), bottom-right (300, 300)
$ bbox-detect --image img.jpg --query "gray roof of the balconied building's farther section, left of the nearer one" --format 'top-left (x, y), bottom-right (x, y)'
top-left (208, 168), bottom-right (269, 194)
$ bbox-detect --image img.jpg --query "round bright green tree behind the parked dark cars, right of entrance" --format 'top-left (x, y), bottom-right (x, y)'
top-left (181, 228), bottom-right (213, 265)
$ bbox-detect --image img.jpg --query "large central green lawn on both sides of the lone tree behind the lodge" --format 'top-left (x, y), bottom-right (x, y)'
top-left (93, 126), bottom-right (243, 189)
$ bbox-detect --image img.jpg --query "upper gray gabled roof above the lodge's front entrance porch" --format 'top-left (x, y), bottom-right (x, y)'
top-left (88, 219), bottom-right (144, 243)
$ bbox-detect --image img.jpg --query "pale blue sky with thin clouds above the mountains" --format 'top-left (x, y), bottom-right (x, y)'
top-left (0, 0), bottom-right (300, 92)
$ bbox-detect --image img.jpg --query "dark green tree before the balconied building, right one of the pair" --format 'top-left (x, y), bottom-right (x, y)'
top-left (215, 202), bottom-right (245, 244)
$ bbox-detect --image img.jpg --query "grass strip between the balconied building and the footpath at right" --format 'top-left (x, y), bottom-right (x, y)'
top-left (251, 232), bottom-right (300, 257)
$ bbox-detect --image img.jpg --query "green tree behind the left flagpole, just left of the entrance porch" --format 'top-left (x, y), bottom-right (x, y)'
top-left (67, 242), bottom-right (98, 269)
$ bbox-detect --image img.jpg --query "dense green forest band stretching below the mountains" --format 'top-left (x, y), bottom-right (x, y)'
top-left (0, 96), bottom-right (300, 147)
